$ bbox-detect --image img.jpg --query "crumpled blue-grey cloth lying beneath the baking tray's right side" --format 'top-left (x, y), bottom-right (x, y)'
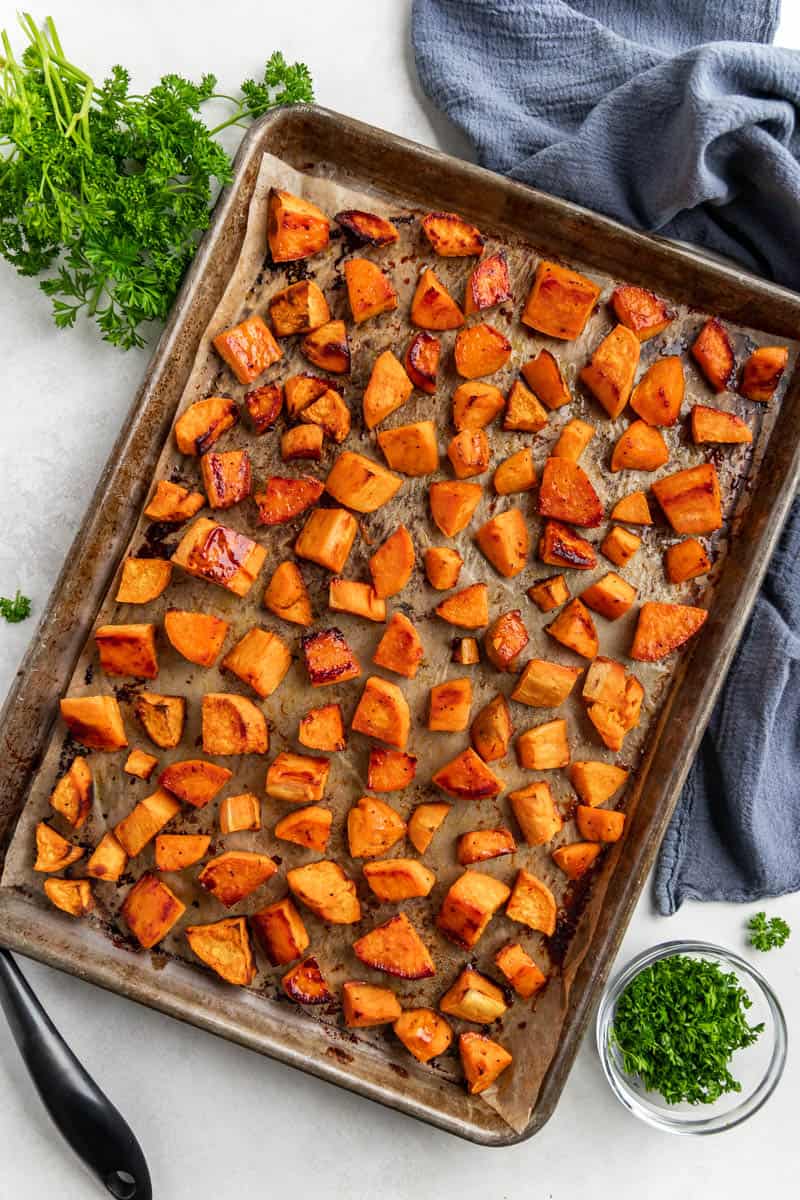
top-left (411, 0), bottom-right (800, 913)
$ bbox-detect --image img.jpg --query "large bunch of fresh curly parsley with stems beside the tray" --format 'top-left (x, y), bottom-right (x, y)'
top-left (0, 13), bottom-right (313, 349)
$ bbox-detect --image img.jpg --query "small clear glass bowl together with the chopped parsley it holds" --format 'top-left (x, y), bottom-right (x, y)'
top-left (597, 942), bottom-right (787, 1134)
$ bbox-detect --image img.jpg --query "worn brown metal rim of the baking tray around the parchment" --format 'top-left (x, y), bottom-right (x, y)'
top-left (0, 106), bottom-right (800, 1146)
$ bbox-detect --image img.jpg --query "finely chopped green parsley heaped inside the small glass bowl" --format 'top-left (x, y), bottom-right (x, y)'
top-left (612, 954), bottom-right (764, 1104)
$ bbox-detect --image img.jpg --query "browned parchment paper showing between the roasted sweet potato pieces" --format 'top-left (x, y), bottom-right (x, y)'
top-left (2, 156), bottom-right (796, 1130)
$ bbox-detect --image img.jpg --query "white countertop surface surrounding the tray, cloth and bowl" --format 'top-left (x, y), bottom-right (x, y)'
top-left (0, 0), bottom-right (800, 1200)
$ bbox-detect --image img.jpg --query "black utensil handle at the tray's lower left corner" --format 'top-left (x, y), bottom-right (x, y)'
top-left (0, 949), bottom-right (152, 1200)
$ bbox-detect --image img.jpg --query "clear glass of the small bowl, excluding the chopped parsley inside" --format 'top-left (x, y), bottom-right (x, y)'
top-left (596, 942), bottom-right (787, 1134)
